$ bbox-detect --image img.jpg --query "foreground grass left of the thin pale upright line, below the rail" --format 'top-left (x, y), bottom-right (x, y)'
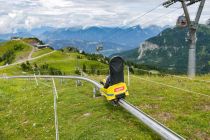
top-left (0, 81), bottom-right (53, 139)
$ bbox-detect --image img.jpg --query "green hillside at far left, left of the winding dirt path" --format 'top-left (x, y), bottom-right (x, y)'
top-left (0, 40), bottom-right (32, 65)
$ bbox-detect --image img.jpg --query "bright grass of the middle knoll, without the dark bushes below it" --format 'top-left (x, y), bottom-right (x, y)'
top-left (0, 51), bottom-right (108, 75)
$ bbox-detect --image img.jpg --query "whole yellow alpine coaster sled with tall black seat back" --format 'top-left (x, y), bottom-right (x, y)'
top-left (100, 57), bottom-right (129, 102)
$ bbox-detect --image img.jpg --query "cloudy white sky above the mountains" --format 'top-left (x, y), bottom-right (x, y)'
top-left (0, 0), bottom-right (210, 33)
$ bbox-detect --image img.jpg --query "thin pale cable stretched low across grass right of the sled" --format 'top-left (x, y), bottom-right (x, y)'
top-left (132, 75), bottom-right (210, 98)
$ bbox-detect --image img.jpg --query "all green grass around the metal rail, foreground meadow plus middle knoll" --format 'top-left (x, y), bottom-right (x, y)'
top-left (0, 45), bottom-right (210, 140)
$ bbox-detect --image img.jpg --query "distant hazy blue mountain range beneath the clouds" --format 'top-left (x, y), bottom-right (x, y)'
top-left (0, 25), bottom-right (167, 56)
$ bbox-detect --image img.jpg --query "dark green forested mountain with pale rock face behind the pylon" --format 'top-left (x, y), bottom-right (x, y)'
top-left (117, 25), bottom-right (210, 73)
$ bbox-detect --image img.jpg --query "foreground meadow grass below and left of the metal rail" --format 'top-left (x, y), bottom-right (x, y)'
top-left (0, 80), bottom-right (158, 139)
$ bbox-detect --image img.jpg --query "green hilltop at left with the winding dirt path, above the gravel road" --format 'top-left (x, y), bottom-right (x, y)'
top-left (0, 38), bottom-right (53, 66)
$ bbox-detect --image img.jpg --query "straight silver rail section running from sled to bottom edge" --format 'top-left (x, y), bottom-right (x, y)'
top-left (118, 99), bottom-right (185, 140)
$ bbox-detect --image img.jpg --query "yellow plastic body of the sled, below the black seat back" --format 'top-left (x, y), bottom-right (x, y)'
top-left (100, 83), bottom-right (129, 101)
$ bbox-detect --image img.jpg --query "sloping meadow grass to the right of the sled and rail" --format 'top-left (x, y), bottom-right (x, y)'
top-left (93, 76), bottom-right (210, 139)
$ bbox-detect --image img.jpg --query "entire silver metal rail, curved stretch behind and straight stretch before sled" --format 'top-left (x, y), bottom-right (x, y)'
top-left (0, 75), bottom-right (184, 140)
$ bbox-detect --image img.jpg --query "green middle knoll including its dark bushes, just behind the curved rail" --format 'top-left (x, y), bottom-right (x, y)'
top-left (0, 51), bottom-right (108, 75)
